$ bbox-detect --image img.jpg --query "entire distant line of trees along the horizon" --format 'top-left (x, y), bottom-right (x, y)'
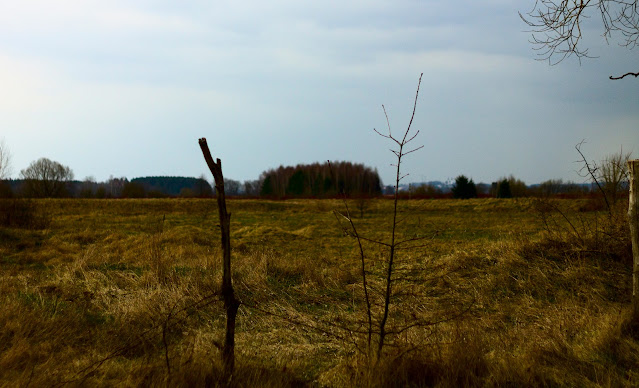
top-left (0, 152), bottom-right (629, 200)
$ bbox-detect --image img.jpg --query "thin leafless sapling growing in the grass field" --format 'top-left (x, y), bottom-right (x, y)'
top-left (334, 74), bottom-right (472, 373)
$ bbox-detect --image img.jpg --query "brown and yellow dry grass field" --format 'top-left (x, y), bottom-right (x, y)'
top-left (0, 199), bottom-right (639, 387)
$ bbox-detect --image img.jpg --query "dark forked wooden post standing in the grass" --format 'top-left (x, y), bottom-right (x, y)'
top-left (199, 138), bottom-right (240, 380)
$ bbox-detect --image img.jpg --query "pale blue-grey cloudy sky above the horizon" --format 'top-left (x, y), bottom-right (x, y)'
top-left (0, 0), bottom-right (639, 184)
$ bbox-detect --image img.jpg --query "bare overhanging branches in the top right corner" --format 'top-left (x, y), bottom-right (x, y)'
top-left (519, 0), bottom-right (639, 79)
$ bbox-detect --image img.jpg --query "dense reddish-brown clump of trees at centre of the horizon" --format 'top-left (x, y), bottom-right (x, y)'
top-left (259, 162), bottom-right (382, 198)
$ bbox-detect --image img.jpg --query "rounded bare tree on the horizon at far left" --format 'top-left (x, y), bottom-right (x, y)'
top-left (20, 158), bottom-right (73, 198)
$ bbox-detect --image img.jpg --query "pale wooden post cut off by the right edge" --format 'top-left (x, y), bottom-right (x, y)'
top-left (628, 159), bottom-right (639, 323)
